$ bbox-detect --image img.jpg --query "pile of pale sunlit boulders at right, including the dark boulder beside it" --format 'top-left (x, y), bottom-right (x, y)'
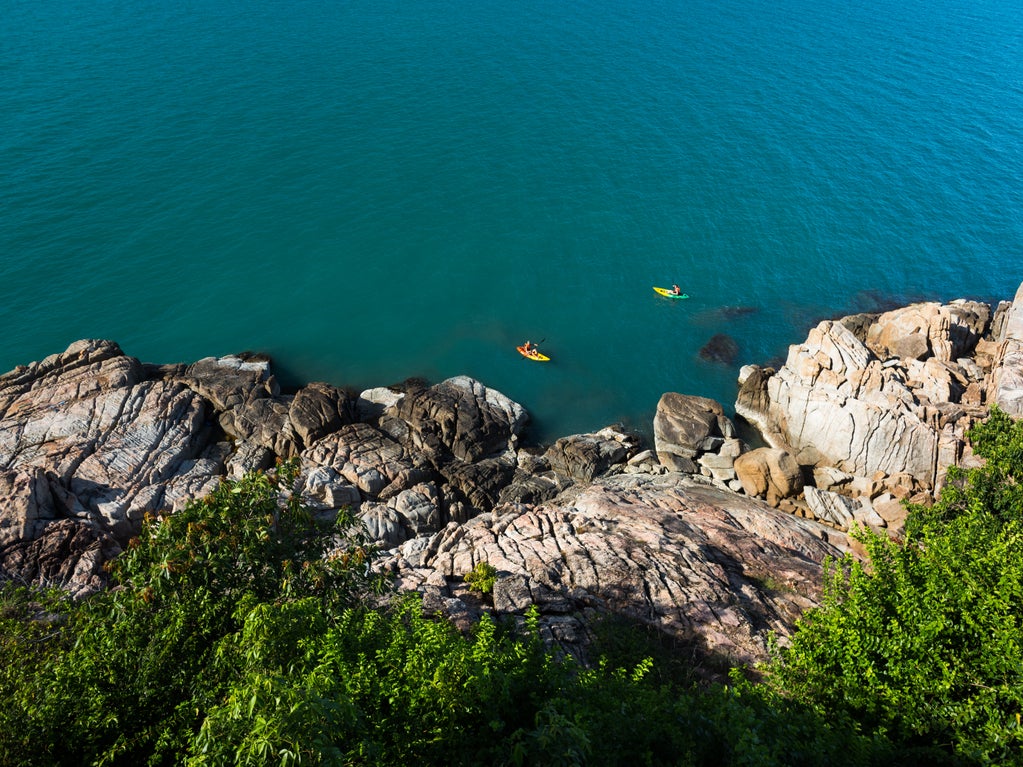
top-left (654, 286), bottom-right (1023, 536)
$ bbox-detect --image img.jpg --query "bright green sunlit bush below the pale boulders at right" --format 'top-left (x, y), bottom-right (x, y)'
top-left (772, 410), bottom-right (1023, 764)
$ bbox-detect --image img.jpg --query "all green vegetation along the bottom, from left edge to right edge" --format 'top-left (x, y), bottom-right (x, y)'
top-left (0, 404), bottom-right (1023, 767)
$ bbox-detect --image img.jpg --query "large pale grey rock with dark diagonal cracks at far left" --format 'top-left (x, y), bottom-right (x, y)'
top-left (0, 342), bottom-right (215, 536)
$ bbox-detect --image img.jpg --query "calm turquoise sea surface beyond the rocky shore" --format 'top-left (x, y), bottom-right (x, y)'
top-left (0, 0), bottom-right (1023, 439)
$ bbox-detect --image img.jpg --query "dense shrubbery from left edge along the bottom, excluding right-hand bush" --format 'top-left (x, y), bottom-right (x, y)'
top-left (0, 464), bottom-right (920, 767)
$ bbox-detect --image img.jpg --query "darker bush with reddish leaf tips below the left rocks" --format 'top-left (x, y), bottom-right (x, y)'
top-left (0, 464), bottom-right (382, 764)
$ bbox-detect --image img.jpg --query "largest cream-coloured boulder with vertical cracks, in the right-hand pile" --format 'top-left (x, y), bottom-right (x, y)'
top-left (736, 313), bottom-right (982, 488)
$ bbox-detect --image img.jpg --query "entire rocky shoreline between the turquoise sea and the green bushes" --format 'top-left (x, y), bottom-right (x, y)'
top-left (0, 285), bottom-right (1023, 663)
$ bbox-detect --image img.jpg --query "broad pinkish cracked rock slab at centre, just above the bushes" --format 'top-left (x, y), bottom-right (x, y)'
top-left (385, 475), bottom-right (843, 663)
